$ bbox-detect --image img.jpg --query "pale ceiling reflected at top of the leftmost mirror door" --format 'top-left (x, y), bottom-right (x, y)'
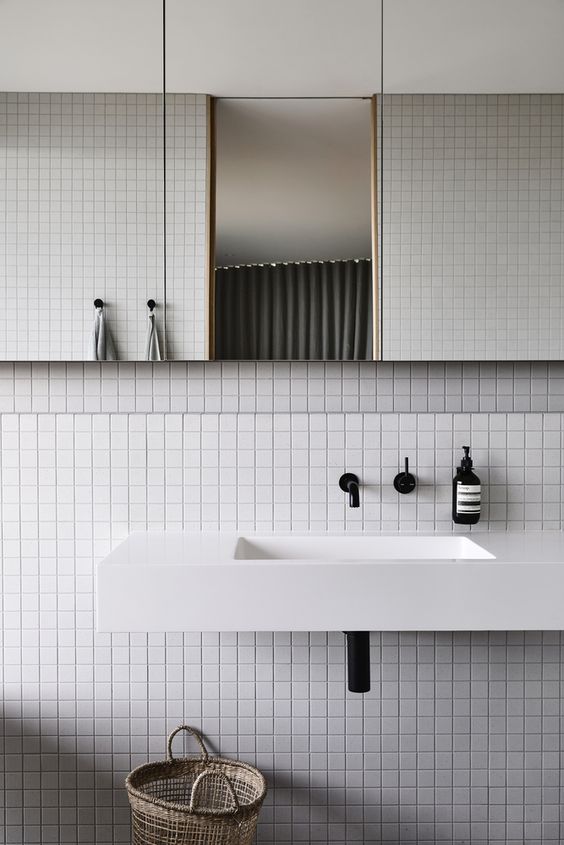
top-left (0, 0), bottom-right (162, 93)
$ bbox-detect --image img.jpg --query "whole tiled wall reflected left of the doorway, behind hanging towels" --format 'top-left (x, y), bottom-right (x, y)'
top-left (0, 92), bottom-right (207, 361)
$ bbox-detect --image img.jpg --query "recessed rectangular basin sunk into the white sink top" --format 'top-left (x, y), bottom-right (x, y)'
top-left (233, 535), bottom-right (494, 562)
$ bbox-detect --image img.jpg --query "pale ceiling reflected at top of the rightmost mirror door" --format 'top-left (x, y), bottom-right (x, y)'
top-left (384, 0), bottom-right (564, 94)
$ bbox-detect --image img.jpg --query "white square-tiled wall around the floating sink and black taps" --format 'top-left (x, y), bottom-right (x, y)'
top-left (0, 398), bottom-right (564, 845)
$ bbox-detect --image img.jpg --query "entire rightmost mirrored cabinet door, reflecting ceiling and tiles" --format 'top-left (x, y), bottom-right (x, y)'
top-left (380, 0), bottom-right (564, 361)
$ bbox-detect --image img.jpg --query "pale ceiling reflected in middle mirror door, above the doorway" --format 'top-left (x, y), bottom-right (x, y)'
top-left (166, 0), bottom-right (380, 97)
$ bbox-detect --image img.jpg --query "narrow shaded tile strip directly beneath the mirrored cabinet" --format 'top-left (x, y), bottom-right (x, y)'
top-left (0, 361), bottom-right (564, 413)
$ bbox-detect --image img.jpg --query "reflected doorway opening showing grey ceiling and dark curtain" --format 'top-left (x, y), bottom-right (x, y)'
top-left (215, 98), bottom-right (373, 360)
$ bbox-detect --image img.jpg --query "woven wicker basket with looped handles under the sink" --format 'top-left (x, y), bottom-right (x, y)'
top-left (125, 725), bottom-right (266, 845)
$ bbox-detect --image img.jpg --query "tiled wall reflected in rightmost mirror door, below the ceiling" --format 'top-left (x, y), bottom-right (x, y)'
top-left (381, 94), bottom-right (564, 361)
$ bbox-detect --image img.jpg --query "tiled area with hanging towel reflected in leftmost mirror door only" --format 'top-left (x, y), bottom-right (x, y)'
top-left (0, 92), bottom-right (164, 361)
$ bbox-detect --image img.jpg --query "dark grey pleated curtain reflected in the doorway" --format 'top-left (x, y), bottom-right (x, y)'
top-left (215, 259), bottom-right (372, 361)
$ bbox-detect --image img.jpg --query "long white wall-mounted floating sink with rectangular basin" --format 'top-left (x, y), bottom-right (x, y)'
top-left (97, 532), bottom-right (564, 632)
